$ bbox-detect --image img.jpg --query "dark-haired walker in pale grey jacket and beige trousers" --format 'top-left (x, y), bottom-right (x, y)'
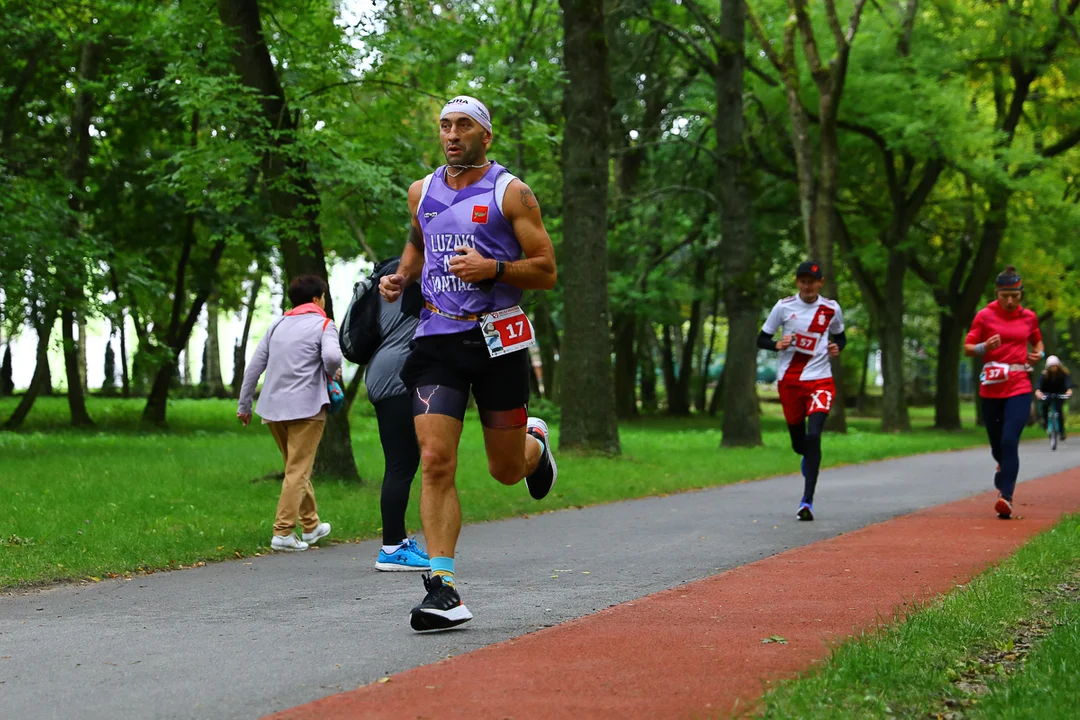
top-left (237, 275), bottom-right (341, 551)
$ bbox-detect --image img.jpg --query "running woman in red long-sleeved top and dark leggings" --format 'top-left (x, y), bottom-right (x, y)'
top-left (963, 266), bottom-right (1045, 518)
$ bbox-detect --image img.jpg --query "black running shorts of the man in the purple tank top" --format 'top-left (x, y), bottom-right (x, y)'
top-left (401, 327), bottom-right (531, 410)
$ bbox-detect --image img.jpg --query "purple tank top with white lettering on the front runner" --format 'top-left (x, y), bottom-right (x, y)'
top-left (416, 163), bottom-right (522, 338)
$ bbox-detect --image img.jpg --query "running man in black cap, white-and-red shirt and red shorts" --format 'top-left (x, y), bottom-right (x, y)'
top-left (757, 261), bottom-right (848, 520)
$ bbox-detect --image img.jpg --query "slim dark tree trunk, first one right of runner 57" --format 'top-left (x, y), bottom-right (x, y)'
top-left (879, 250), bottom-right (912, 433)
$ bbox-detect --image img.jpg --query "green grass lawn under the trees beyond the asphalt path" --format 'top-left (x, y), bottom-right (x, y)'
top-left (0, 397), bottom-right (985, 587)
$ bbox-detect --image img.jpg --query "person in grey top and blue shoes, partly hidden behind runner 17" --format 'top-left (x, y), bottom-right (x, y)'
top-left (364, 262), bottom-right (431, 571)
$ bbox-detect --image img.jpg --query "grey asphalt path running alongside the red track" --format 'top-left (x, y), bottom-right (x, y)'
top-left (0, 441), bottom-right (1080, 720)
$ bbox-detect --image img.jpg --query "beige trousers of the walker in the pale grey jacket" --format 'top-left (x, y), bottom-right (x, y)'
top-left (267, 417), bottom-right (326, 535)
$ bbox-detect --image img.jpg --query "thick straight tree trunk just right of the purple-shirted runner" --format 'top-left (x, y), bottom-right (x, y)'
top-left (558, 0), bottom-right (620, 453)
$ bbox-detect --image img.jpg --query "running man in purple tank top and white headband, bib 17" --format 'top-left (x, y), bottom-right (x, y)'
top-left (379, 95), bottom-right (557, 630)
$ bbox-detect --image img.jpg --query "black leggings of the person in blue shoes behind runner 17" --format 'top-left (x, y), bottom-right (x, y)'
top-left (375, 395), bottom-right (420, 545)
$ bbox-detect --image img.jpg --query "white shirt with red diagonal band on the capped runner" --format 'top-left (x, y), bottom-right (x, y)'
top-left (761, 295), bottom-right (843, 383)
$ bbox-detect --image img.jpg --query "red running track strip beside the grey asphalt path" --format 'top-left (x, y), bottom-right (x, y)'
top-left (272, 470), bottom-right (1080, 720)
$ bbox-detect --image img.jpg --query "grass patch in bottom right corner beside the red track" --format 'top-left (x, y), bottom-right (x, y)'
top-left (760, 516), bottom-right (1080, 720)
